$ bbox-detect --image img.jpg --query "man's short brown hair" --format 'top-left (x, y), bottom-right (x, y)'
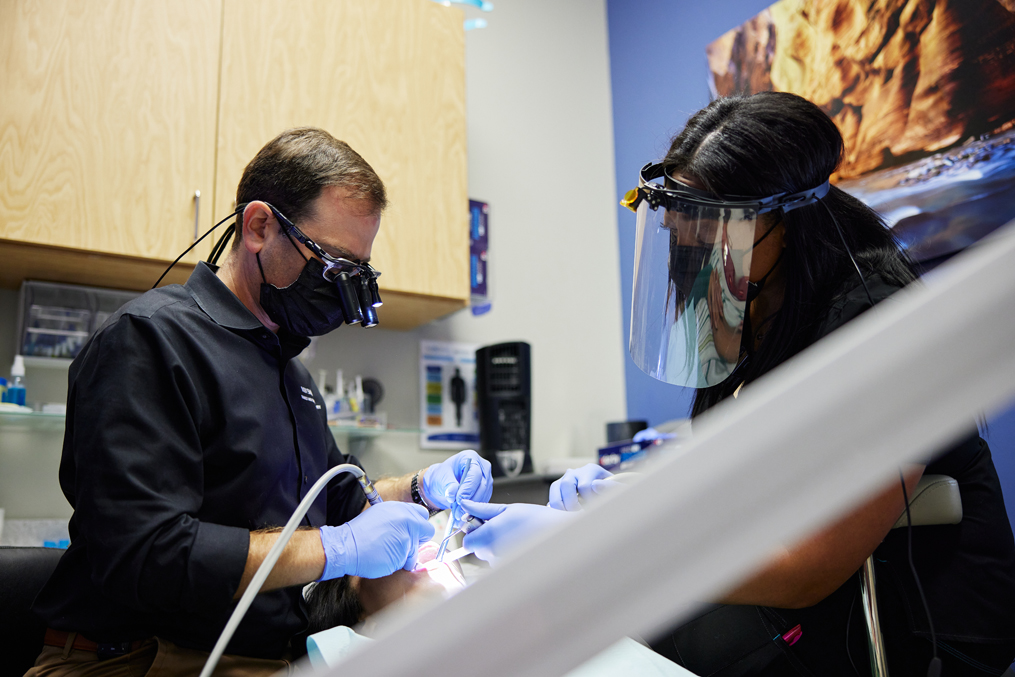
top-left (233, 127), bottom-right (388, 247)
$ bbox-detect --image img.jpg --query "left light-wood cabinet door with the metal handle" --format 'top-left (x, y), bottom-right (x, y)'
top-left (0, 0), bottom-right (221, 263)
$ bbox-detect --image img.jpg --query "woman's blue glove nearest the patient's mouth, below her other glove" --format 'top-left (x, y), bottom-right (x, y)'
top-left (462, 500), bottom-right (577, 564)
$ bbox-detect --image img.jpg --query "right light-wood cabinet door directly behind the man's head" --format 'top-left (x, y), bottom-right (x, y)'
top-left (215, 0), bottom-right (469, 327)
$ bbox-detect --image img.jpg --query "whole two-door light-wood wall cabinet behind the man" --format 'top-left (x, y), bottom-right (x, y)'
top-left (0, 0), bottom-right (469, 328)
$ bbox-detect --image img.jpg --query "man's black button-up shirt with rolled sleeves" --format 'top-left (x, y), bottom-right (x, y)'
top-left (35, 264), bottom-right (365, 659)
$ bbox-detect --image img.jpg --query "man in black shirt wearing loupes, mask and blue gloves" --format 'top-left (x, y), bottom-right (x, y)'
top-left (27, 128), bottom-right (492, 677)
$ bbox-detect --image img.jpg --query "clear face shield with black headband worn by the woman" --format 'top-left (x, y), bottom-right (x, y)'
top-left (621, 164), bottom-right (829, 388)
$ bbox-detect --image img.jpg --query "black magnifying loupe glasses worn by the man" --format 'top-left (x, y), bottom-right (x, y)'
top-left (265, 202), bottom-right (383, 327)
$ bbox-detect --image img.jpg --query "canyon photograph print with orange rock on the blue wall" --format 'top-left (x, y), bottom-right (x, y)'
top-left (706, 0), bottom-right (1015, 270)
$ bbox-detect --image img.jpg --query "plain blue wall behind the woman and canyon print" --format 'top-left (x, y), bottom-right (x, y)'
top-left (607, 0), bottom-right (1015, 518)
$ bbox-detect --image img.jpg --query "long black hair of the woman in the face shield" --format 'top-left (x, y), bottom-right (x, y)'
top-left (664, 91), bottom-right (916, 416)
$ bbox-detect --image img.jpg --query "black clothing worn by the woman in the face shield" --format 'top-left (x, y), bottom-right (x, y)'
top-left (653, 275), bottom-right (1015, 677)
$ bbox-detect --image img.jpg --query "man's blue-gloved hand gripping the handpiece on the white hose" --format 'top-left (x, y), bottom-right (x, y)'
top-left (318, 500), bottom-right (433, 581)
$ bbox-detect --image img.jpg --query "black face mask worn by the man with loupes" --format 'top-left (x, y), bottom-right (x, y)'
top-left (257, 254), bottom-right (345, 336)
